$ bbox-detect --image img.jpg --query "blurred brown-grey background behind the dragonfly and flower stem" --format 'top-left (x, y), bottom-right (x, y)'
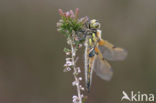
top-left (0, 0), bottom-right (156, 103)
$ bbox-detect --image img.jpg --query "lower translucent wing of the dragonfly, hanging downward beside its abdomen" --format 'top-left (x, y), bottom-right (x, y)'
top-left (94, 55), bottom-right (113, 81)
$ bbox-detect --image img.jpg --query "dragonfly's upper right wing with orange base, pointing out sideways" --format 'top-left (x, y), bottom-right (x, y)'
top-left (98, 39), bottom-right (127, 61)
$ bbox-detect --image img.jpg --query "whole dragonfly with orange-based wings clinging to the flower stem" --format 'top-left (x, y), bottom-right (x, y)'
top-left (84, 19), bottom-right (127, 91)
